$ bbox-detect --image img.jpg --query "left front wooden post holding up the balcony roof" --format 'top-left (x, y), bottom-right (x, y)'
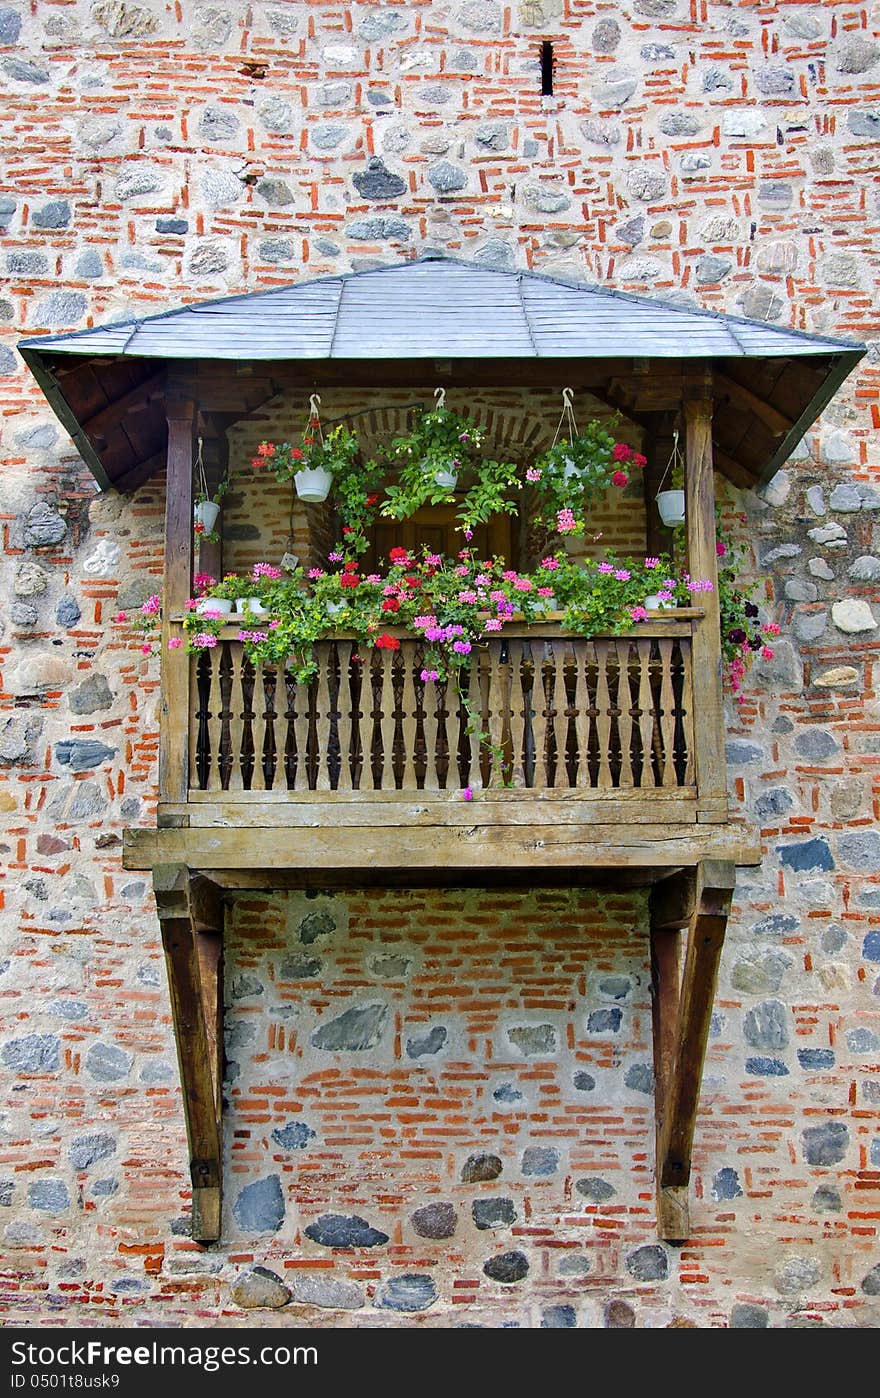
top-left (159, 398), bottom-right (196, 819)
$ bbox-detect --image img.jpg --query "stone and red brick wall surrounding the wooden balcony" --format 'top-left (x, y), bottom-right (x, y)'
top-left (0, 0), bottom-right (880, 1327)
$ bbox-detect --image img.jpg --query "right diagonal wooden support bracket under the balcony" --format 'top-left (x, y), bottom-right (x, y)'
top-left (651, 860), bottom-right (736, 1241)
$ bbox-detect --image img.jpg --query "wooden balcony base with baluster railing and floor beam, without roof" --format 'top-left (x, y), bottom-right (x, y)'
top-left (120, 610), bottom-right (750, 875)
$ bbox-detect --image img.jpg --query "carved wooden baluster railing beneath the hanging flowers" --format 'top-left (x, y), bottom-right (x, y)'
top-left (178, 612), bottom-right (701, 818)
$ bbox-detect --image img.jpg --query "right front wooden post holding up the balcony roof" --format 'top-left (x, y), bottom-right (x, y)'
top-left (684, 370), bottom-right (728, 822)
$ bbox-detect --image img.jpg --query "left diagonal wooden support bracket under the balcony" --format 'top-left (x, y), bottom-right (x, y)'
top-left (152, 864), bottom-right (224, 1243)
